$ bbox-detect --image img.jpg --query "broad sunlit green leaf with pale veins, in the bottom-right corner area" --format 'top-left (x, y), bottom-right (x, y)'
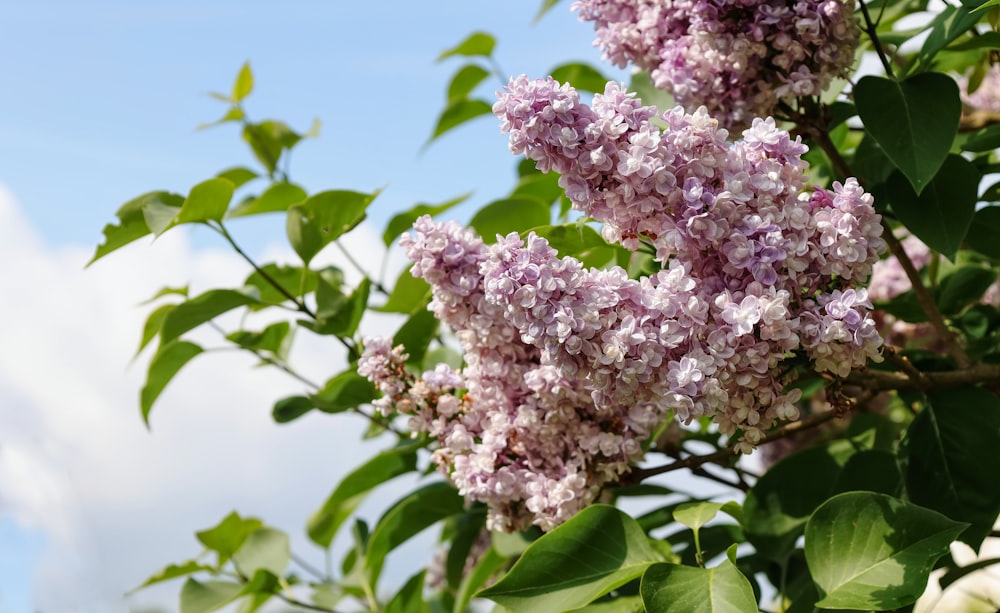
top-left (805, 492), bottom-right (965, 611)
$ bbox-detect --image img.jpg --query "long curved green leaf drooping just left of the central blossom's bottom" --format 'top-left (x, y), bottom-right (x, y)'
top-left (306, 443), bottom-right (420, 548)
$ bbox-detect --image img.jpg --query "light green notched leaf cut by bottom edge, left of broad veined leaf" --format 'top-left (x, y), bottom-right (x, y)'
top-left (639, 559), bottom-right (757, 613)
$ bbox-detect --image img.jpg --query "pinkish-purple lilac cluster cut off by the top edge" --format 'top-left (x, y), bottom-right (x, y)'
top-left (573, 0), bottom-right (859, 127)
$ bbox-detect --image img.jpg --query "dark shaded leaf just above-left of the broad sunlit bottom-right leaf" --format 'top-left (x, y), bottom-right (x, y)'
top-left (743, 439), bottom-right (864, 561)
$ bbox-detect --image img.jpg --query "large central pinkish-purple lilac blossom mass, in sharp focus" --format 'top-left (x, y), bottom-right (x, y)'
top-left (359, 77), bottom-right (885, 530)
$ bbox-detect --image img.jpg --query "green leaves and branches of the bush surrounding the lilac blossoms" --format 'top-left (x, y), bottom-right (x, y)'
top-left (103, 10), bottom-right (1000, 613)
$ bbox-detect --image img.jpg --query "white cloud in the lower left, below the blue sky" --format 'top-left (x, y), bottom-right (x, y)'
top-left (0, 186), bottom-right (424, 613)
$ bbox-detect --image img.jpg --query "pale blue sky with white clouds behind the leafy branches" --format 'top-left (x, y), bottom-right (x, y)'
top-left (0, 0), bottom-right (640, 613)
